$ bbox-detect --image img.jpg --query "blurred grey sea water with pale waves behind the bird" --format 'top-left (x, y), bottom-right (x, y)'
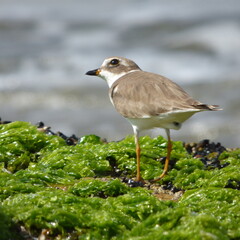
top-left (0, 0), bottom-right (240, 147)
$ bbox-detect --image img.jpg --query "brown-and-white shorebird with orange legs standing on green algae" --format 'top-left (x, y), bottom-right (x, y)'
top-left (86, 57), bottom-right (221, 181)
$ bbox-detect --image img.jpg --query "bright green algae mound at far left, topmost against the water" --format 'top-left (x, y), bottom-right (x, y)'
top-left (0, 122), bottom-right (64, 172)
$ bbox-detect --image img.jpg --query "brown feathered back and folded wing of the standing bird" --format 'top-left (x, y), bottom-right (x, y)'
top-left (109, 71), bottom-right (216, 118)
